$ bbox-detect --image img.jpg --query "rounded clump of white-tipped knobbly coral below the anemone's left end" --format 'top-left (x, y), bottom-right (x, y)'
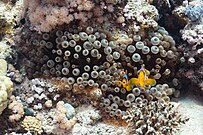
top-left (14, 78), bottom-right (59, 111)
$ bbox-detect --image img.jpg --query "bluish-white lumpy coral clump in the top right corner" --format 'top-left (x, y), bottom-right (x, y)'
top-left (173, 0), bottom-right (203, 45)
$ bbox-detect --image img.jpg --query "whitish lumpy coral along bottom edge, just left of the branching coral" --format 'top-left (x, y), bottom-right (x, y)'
top-left (72, 105), bottom-right (128, 135)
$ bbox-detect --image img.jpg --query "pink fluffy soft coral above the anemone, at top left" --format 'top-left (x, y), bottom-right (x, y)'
top-left (25, 0), bottom-right (94, 32)
